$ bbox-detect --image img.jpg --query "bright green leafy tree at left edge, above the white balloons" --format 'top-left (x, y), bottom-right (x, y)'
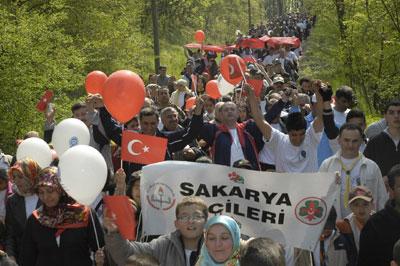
top-left (0, 2), bottom-right (86, 154)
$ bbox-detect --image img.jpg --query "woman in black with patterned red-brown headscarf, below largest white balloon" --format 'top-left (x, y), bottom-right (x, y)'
top-left (21, 167), bottom-right (104, 266)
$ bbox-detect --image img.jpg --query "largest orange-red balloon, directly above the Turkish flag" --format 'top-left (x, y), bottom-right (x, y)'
top-left (103, 70), bottom-right (146, 123)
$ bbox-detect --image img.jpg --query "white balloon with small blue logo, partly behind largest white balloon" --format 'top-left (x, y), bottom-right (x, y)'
top-left (51, 118), bottom-right (90, 157)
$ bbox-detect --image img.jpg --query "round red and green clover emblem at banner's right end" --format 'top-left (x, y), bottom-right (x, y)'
top-left (295, 197), bottom-right (327, 225)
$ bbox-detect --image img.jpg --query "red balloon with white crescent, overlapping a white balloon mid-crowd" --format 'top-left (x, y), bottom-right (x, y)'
top-left (221, 54), bottom-right (246, 85)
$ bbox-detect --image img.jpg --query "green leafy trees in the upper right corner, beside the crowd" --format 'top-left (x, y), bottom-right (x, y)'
top-left (303, 0), bottom-right (400, 116)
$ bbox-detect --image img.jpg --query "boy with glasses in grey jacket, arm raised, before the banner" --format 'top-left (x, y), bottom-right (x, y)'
top-left (104, 197), bottom-right (208, 266)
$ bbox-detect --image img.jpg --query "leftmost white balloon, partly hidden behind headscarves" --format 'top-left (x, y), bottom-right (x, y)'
top-left (17, 137), bottom-right (52, 168)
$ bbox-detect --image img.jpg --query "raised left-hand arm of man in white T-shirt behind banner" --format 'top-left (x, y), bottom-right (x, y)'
top-left (243, 84), bottom-right (272, 140)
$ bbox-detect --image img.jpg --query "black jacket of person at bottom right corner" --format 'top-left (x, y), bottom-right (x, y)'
top-left (358, 201), bottom-right (400, 266)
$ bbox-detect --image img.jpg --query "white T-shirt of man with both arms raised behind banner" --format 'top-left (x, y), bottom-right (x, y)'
top-left (261, 123), bottom-right (322, 173)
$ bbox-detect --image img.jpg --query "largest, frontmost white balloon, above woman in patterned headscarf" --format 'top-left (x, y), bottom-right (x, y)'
top-left (58, 145), bottom-right (107, 205)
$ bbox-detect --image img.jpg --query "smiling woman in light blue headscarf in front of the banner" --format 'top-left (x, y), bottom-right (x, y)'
top-left (196, 215), bottom-right (240, 266)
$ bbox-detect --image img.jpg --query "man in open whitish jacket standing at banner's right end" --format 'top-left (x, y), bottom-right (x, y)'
top-left (320, 123), bottom-right (388, 219)
